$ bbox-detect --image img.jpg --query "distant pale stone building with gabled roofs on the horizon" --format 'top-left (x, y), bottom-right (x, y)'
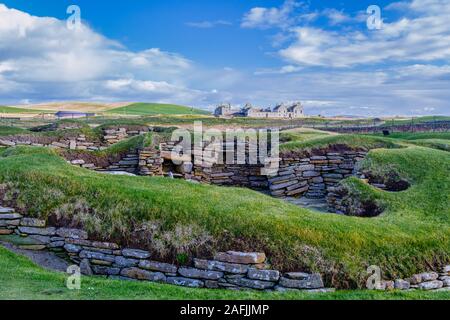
top-left (214, 102), bottom-right (305, 119)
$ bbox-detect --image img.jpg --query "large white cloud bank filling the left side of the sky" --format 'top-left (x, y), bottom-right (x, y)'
top-left (0, 4), bottom-right (202, 102)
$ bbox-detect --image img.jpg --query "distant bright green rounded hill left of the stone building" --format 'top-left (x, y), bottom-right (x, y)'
top-left (107, 103), bottom-right (210, 116)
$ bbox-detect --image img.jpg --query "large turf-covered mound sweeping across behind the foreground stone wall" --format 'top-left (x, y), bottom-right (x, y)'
top-left (0, 147), bottom-right (450, 288)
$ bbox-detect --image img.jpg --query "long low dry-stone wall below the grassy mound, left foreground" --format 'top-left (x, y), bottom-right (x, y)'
top-left (0, 207), bottom-right (323, 290)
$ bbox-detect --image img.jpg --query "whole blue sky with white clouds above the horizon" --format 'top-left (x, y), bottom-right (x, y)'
top-left (0, 0), bottom-right (450, 115)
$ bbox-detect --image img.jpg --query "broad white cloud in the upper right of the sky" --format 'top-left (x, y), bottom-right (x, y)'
top-left (280, 0), bottom-right (450, 67)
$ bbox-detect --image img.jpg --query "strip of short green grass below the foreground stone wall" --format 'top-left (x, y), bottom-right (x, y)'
top-left (0, 246), bottom-right (450, 300)
